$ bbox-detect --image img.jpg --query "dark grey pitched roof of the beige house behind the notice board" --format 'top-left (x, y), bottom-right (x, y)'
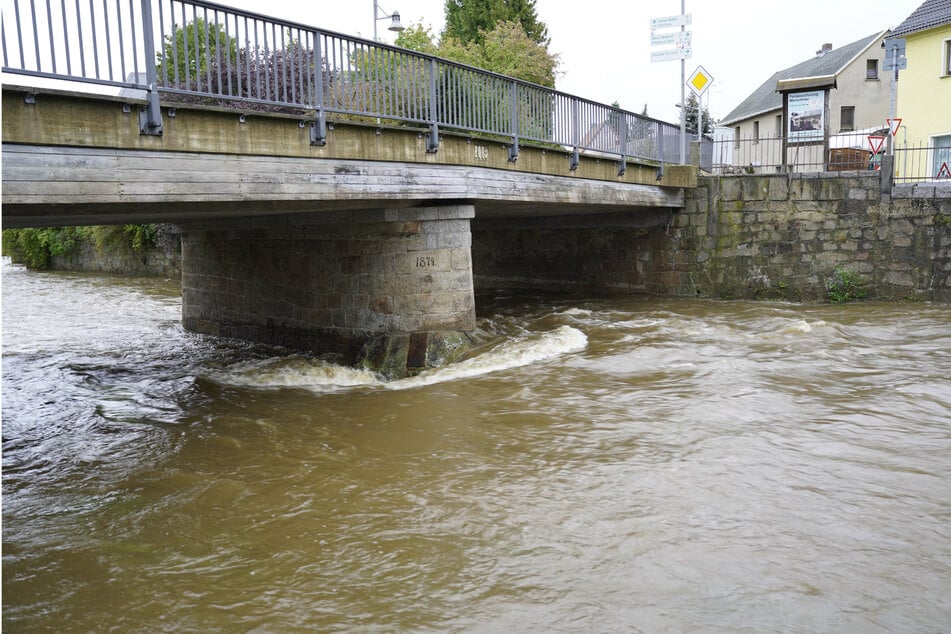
top-left (720, 31), bottom-right (888, 125)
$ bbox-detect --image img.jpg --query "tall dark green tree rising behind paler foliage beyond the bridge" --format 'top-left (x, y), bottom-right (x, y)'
top-left (443, 0), bottom-right (549, 48)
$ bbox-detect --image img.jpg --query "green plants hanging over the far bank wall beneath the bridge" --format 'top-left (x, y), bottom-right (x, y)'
top-left (3, 225), bottom-right (163, 270)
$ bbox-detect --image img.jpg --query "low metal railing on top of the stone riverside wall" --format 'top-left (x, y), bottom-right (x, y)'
top-left (702, 129), bottom-right (951, 182)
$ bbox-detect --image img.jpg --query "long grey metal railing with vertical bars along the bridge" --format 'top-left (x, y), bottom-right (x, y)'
top-left (2, 0), bottom-right (685, 168)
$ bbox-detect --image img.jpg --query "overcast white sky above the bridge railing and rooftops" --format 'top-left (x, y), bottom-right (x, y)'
top-left (217, 0), bottom-right (921, 122)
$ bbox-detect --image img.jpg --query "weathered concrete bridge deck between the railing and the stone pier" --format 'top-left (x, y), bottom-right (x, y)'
top-left (3, 86), bottom-right (696, 228)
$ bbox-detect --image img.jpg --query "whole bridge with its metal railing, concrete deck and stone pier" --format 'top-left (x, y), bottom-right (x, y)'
top-left (2, 0), bottom-right (696, 376)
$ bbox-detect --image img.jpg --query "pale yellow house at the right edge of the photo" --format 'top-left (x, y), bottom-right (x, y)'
top-left (889, 0), bottom-right (951, 181)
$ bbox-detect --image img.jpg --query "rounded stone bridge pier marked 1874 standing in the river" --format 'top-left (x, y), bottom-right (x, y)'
top-left (180, 205), bottom-right (475, 378)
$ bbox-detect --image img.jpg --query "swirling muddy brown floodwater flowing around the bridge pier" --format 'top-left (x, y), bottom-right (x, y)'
top-left (2, 259), bottom-right (951, 634)
